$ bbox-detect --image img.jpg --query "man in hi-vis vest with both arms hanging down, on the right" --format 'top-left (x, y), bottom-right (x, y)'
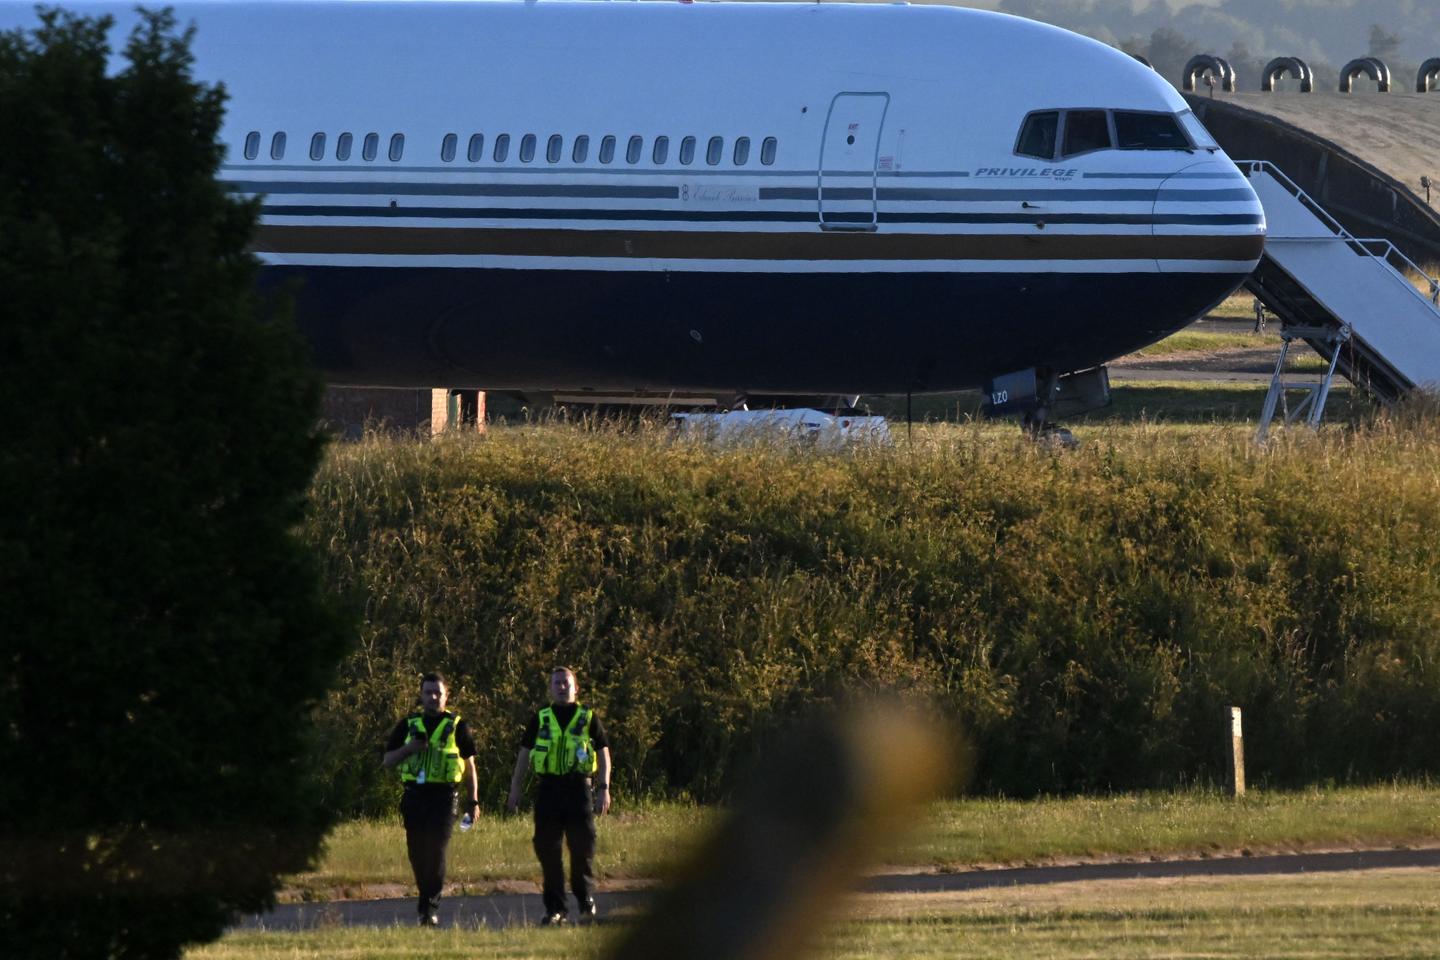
top-left (505, 666), bottom-right (611, 924)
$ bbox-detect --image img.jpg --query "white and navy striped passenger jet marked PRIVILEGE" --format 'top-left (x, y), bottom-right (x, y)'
top-left (0, 0), bottom-right (1266, 423)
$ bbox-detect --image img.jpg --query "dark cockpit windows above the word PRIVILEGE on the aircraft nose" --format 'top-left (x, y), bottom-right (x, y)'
top-left (1015, 109), bottom-right (1204, 160)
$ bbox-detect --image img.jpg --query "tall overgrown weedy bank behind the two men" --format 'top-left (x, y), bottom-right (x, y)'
top-left (308, 422), bottom-right (1440, 812)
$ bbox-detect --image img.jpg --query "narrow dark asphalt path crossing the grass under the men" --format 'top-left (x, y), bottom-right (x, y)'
top-left (233, 848), bottom-right (1440, 931)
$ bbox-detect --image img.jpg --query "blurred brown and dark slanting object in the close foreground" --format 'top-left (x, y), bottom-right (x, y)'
top-left (609, 702), bottom-right (971, 960)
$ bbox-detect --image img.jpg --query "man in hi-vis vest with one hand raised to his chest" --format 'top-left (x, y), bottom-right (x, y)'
top-left (382, 674), bottom-right (480, 927)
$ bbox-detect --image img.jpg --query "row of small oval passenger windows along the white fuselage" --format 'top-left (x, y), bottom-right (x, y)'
top-left (245, 130), bottom-right (779, 167)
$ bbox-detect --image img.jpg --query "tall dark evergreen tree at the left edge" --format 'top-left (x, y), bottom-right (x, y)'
top-left (0, 10), bottom-right (347, 957)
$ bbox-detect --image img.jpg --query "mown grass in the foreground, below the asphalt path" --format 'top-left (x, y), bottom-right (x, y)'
top-left (186, 869), bottom-right (1440, 960)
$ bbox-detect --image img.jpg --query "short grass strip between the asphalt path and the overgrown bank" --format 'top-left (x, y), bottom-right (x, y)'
top-left (289, 784), bottom-right (1440, 898)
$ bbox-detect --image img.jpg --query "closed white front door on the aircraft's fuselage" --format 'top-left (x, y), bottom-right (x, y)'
top-left (819, 94), bottom-right (890, 230)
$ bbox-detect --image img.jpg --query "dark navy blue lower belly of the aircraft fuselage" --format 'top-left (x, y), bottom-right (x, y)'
top-left (264, 266), bottom-right (1246, 396)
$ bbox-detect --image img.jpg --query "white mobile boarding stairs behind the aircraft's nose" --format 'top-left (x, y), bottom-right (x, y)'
top-left (1240, 160), bottom-right (1440, 442)
